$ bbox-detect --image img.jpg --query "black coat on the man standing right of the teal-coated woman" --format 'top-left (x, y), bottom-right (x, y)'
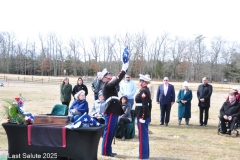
top-left (197, 84), bottom-right (212, 108)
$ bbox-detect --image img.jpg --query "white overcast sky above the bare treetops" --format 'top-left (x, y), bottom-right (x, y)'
top-left (0, 0), bottom-right (240, 42)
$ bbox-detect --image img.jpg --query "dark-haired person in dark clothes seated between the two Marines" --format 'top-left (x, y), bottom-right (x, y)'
top-left (117, 96), bottom-right (132, 141)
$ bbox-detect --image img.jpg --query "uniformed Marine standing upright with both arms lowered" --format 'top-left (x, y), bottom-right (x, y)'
top-left (134, 74), bottom-right (151, 159)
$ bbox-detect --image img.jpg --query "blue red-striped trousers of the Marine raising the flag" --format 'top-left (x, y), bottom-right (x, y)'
top-left (102, 113), bottom-right (118, 155)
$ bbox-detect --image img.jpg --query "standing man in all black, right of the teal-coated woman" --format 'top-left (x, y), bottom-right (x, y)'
top-left (197, 77), bottom-right (212, 126)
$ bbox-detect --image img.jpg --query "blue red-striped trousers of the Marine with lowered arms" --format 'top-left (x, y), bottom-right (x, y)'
top-left (137, 118), bottom-right (150, 159)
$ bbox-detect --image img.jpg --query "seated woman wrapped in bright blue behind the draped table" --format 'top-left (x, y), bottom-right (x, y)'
top-left (69, 90), bottom-right (88, 122)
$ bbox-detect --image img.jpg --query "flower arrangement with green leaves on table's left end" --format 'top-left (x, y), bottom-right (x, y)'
top-left (4, 94), bottom-right (34, 124)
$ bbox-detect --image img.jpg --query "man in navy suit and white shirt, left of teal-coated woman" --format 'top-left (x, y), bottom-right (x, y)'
top-left (156, 77), bottom-right (175, 126)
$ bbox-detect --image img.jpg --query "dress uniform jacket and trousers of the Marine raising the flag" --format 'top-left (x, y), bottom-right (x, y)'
top-left (102, 71), bottom-right (126, 155)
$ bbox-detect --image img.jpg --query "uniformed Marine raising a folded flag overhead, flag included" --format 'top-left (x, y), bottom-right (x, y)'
top-left (101, 45), bottom-right (129, 157)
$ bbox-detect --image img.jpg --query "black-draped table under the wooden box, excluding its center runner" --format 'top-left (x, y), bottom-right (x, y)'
top-left (2, 123), bottom-right (105, 160)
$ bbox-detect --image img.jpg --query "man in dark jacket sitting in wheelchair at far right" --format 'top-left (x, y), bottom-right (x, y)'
top-left (219, 93), bottom-right (240, 135)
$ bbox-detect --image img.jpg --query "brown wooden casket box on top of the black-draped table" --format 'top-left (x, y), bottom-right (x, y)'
top-left (33, 114), bottom-right (69, 126)
